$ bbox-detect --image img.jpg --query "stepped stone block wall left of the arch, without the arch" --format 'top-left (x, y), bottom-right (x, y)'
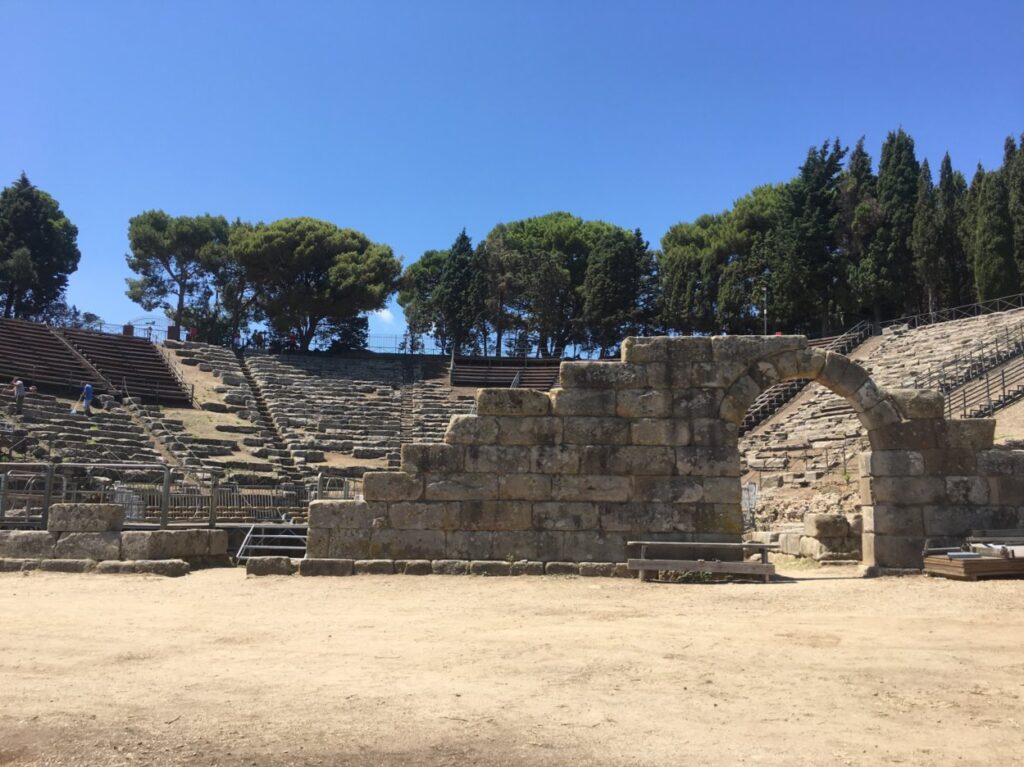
top-left (307, 337), bottom-right (806, 562)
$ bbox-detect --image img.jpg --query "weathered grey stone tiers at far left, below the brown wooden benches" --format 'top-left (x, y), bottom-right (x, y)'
top-left (0, 393), bottom-right (163, 463)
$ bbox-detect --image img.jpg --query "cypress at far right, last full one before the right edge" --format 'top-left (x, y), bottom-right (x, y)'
top-left (973, 172), bottom-right (1020, 301)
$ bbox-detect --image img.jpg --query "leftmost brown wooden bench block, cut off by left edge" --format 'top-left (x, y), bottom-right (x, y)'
top-left (0, 319), bottom-right (97, 394)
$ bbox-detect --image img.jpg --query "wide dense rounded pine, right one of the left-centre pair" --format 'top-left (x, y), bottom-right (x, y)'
top-left (236, 218), bottom-right (401, 349)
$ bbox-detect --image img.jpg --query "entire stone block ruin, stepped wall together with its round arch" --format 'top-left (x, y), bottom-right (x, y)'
top-left (306, 336), bottom-right (1024, 568)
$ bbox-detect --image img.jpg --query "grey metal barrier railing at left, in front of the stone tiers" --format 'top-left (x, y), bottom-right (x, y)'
top-left (0, 463), bottom-right (361, 527)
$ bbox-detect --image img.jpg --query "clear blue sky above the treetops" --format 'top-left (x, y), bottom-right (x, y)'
top-left (0, 0), bottom-right (1024, 342)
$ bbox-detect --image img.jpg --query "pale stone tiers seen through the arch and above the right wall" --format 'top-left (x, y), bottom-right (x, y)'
top-left (740, 309), bottom-right (1024, 518)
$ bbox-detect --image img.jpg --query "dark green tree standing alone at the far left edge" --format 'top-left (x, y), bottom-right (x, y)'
top-left (0, 173), bottom-right (81, 318)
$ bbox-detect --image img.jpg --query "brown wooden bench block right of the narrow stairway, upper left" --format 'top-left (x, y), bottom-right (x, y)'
top-left (59, 329), bottom-right (191, 407)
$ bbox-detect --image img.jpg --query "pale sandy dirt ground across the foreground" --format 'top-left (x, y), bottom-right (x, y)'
top-left (0, 568), bottom-right (1024, 766)
